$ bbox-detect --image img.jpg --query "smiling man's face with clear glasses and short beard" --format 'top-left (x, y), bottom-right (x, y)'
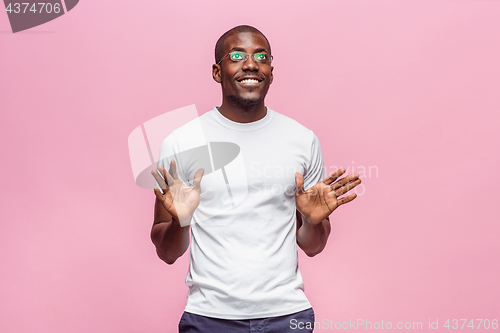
top-left (213, 32), bottom-right (273, 107)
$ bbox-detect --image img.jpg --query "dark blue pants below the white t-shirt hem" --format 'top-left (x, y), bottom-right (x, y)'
top-left (179, 308), bottom-right (314, 333)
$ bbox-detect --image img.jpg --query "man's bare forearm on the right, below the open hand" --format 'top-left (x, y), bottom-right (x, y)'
top-left (297, 210), bottom-right (331, 257)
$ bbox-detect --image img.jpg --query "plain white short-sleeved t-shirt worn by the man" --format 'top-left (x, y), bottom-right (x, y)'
top-left (158, 108), bottom-right (325, 319)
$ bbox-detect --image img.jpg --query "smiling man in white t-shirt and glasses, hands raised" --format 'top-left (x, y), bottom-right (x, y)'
top-left (151, 26), bottom-right (361, 333)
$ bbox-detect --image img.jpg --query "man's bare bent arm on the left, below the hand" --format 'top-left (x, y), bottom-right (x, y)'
top-left (151, 198), bottom-right (189, 265)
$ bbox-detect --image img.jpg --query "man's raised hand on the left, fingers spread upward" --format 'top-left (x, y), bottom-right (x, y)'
top-left (151, 160), bottom-right (205, 226)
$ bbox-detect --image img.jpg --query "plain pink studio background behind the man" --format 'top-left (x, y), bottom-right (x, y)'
top-left (0, 0), bottom-right (500, 333)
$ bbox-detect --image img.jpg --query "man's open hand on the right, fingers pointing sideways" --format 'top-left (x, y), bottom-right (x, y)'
top-left (295, 169), bottom-right (361, 224)
